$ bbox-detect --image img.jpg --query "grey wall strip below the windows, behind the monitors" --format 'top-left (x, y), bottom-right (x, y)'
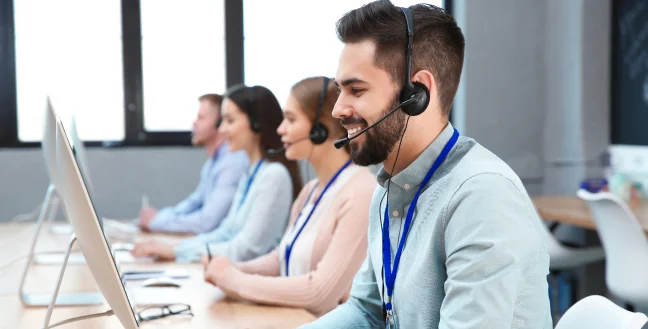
top-left (0, 147), bottom-right (206, 221)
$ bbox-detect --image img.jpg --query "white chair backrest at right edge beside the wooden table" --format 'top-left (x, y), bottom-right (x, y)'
top-left (577, 189), bottom-right (648, 302)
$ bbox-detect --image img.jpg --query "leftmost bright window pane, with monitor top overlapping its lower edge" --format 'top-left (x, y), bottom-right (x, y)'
top-left (14, 0), bottom-right (124, 142)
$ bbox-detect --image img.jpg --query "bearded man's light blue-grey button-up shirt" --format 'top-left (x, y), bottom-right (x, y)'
top-left (303, 124), bottom-right (553, 329)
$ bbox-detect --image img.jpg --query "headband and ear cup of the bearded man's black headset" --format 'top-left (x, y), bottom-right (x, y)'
top-left (399, 7), bottom-right (430, 116)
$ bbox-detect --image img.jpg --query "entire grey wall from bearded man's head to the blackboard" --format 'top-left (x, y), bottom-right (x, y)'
top-left (454, 0), bottom-right (611, 194)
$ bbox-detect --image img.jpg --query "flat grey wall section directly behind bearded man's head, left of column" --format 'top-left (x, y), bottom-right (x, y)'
top-left (454, 0), bottom-right (546, 193)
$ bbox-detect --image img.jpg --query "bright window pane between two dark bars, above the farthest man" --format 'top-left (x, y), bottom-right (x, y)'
top-left (140, 0), bottom-right (226, 131)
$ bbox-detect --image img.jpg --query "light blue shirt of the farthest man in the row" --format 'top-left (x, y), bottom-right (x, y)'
top-left (149, 143), bottom-right (249, 234)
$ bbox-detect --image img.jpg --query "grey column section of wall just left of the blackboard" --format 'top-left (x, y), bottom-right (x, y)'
top-left (544, 0), bottom-right (611, 195)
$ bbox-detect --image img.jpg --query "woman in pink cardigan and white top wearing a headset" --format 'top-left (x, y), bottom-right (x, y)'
top-left (203, 77), bottom-right (376, 316)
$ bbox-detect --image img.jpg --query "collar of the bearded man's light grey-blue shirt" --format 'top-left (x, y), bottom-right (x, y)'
top-left (376, 122), bottom-right (454, 190)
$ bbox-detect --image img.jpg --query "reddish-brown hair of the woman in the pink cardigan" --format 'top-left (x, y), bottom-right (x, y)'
top-left (290, 76), bottom-right (351, 153)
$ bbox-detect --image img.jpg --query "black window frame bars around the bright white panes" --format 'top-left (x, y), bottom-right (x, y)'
top-left (0, 0), bottom-right (453, 149)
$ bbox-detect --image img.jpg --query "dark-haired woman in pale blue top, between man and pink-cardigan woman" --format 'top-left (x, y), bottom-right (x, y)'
top-left (132, 85), bottom-right (301, 261)
